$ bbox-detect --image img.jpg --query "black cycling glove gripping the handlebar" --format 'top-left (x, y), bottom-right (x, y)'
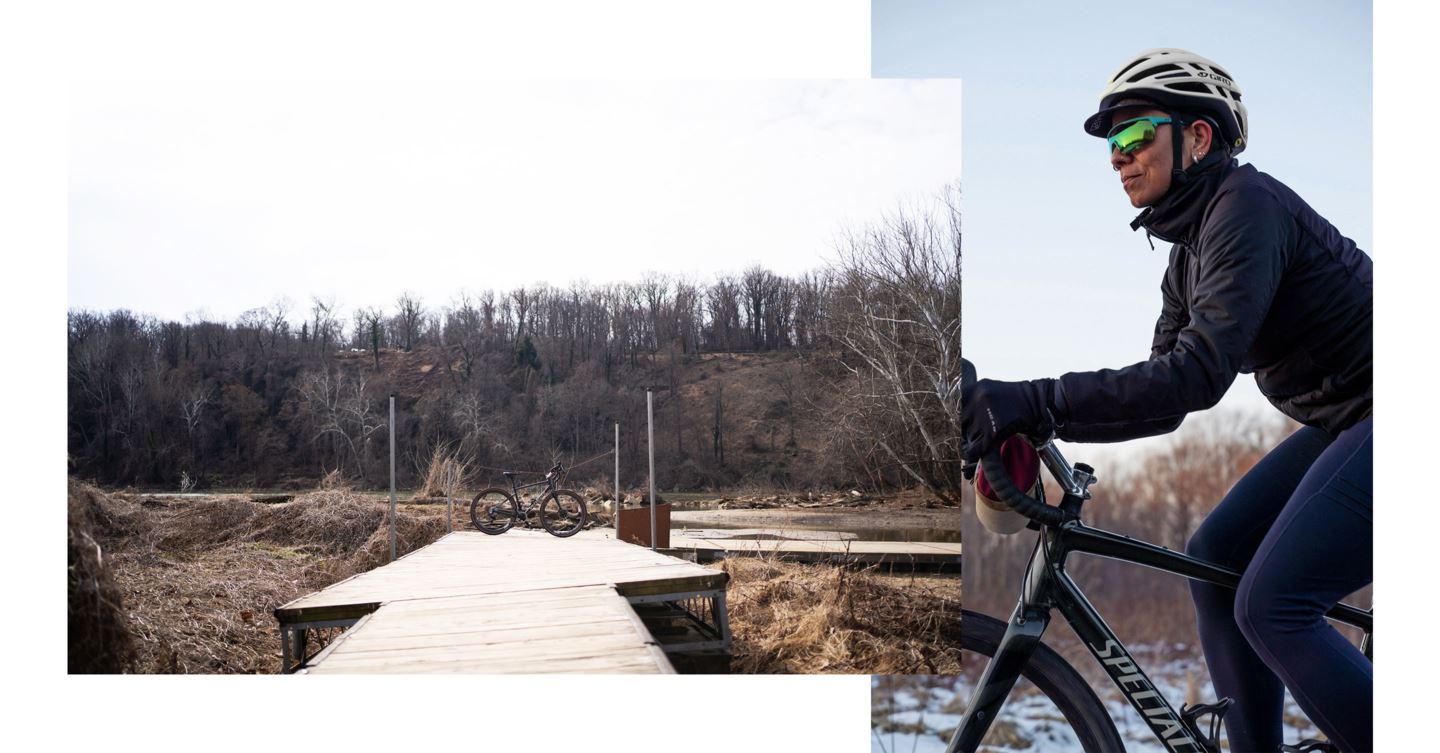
top-left (960, 379), bottom-right (1056, 462)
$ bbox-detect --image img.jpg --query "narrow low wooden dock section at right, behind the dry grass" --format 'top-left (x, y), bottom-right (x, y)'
top-left (668, 531), bottom-right (960, 570)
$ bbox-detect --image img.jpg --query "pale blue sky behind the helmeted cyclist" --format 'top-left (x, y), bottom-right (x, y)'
top-left (871, 0), bottom-right (1375, 458)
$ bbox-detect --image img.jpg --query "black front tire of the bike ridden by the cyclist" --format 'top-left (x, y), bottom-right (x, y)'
top-left (960, 609), bottom-right (1125, 753)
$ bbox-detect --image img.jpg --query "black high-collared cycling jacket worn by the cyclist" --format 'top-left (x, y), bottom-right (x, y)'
top-left (1053, 160), bottom-right (1372, 442)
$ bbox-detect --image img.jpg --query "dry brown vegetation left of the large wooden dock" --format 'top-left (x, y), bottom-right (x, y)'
top-left (69, 479), bottom-right (445, 672)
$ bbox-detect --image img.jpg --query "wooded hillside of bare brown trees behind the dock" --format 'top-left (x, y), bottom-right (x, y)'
top-left (68, 190), bottom-right (960, 502)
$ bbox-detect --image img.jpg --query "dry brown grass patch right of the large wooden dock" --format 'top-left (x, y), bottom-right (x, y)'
top-left (721, 557), bottom-right (960, 674)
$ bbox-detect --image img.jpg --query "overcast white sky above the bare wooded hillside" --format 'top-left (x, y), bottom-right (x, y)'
top-left (69, 79), bottom-right (960, 318)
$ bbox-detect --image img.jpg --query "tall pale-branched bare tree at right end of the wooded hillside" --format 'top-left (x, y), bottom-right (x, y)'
top-left (829, 187), bottom-right (962, 504)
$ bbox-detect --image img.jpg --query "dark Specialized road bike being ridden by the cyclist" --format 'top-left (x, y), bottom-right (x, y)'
top-left (946, 377), bottom-right (1374, 753)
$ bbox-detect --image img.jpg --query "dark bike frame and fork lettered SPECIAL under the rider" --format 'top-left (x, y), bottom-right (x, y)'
top-left (946, 443), bottom-right (1374, 753)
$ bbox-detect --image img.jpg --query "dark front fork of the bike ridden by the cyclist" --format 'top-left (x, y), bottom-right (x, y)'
top-left (945, 535), bottom-right (1051, 753)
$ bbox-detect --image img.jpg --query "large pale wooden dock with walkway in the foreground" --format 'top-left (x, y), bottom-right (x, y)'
top-left (275, 530), bottom-right (730, 674)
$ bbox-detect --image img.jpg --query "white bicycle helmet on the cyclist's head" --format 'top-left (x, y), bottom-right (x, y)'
top-left (1084, 48), bottom-right (1250, 154)
